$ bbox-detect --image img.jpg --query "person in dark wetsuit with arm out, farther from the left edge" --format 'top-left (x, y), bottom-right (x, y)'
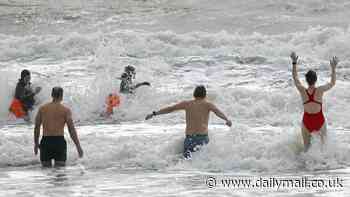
top-left (119, 65), bottom-right (151, 94)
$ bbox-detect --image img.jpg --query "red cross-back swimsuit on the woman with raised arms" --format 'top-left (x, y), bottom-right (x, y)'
top-left (303, 88), bottom-right (325, 133)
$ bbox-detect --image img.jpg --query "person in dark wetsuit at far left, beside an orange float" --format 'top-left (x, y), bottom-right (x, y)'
top-left (15, 70), bottom-right (41, 115)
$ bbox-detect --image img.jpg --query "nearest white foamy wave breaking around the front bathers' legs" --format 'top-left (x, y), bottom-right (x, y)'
top-left (0, 124), bottom-right (350, 173)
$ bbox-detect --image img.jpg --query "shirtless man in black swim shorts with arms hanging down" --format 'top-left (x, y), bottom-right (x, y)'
top-left (34, 87), bottom-right (83, 167)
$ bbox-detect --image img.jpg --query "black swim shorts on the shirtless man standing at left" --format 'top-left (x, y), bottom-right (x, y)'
top-left (40, 136), bottom-right (67, 162)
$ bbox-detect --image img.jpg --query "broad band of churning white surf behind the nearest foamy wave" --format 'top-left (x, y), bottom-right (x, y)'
top-left (0, 27), bottom-right (350, 127)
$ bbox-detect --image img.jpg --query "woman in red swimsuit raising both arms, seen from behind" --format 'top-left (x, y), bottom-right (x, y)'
top-left (290, 52), bottom-right (339, 151)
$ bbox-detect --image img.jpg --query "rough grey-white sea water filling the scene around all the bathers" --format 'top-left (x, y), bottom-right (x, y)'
top-left (0, 0), bottom-right (350, 196)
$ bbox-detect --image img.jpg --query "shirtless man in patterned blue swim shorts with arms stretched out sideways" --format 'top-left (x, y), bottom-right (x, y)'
top-left (146, 86), bottom-right (232, 158)
